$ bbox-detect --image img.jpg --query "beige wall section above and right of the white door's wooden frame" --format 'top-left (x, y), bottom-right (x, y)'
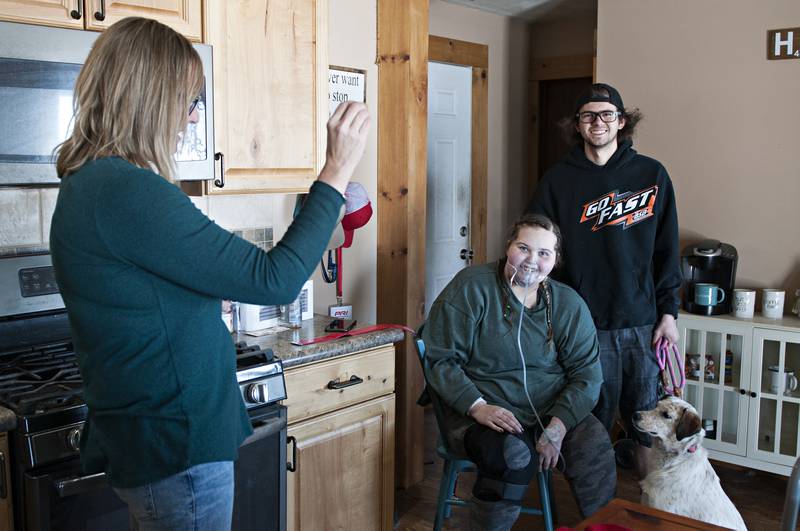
top-left (429, 0), bottom-right (529, 260)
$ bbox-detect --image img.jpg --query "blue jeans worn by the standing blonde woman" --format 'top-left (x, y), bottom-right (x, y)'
top-left (114, 461), bottom-right (233, 531)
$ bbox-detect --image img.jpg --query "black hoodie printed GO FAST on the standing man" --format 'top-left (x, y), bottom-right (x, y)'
top-left (526, 140), bottom-right (681, 330)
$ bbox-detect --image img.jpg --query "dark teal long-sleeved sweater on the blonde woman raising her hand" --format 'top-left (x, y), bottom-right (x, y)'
top-left (50, 158), bottom-right (344, 488)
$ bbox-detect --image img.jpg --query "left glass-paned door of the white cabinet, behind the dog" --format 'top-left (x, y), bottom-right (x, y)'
top-left (678, 316), bottom-right (752, 456)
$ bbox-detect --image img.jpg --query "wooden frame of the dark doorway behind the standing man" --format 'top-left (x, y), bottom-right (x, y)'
top-left (528, 55), bottom-right (595, 197)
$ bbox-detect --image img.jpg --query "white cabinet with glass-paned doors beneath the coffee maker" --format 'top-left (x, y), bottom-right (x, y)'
top-left (678, 313), bottom-right (800, 475)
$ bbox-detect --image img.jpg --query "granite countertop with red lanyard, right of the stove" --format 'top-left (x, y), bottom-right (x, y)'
top-left (233, 314), bottom-right (405, 369)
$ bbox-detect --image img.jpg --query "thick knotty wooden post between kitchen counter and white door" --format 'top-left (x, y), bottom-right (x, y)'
top-left (377, 0), bottom-right (428, 487)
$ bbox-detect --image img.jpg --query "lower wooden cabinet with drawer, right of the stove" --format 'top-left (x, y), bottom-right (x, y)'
top-left (285, 345), bottom-right (395, 531)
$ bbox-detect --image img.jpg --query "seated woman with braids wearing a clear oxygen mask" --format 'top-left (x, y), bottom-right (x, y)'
top-left (422, 215), bottom-right (616, 530)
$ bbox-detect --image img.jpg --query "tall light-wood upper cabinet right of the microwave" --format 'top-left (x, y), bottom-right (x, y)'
top-left (202, 0), bottom-right (328, 194)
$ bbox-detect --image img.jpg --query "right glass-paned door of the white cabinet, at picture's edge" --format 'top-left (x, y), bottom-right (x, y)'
top-left (750, 328), bottom-right (800, 466)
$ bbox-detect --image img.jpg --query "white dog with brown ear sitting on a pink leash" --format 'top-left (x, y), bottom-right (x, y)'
top-left (633, 396), bottom-right (747, 530)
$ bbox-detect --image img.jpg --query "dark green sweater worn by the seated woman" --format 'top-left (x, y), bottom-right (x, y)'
top-left (422, 262), bottom-right (603, 429)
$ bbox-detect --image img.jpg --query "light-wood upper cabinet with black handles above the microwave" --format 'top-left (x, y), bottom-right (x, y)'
top-left (0, 0), bottom-right (203, 42)
